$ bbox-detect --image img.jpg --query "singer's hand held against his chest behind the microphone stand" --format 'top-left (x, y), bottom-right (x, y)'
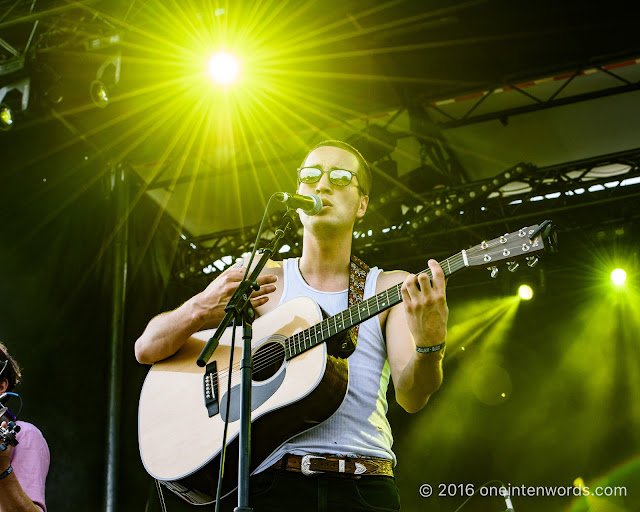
top-left (193, 267), bottom-right (278, 328)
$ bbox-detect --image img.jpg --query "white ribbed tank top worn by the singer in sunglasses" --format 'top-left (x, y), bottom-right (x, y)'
top-left (254, 258), bottom-right (396, 474)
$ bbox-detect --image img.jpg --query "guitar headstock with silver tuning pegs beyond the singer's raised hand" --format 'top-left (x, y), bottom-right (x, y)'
top-left (464, 220), bottom-right (557, 271)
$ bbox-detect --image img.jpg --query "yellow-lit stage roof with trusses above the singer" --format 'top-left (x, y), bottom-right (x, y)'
top-left (0, 0), bottom-right (640, 278)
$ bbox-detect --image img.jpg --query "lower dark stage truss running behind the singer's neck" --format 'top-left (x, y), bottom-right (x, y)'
top-left (174, 149), bottom-right (640, 287)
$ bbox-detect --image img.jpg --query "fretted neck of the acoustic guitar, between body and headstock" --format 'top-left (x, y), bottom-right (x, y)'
top-left (285, 251), bottom-right (468, 359)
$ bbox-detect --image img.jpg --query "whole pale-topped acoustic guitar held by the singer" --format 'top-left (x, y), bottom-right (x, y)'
top-left (138, 221), bottom-right (556, 504)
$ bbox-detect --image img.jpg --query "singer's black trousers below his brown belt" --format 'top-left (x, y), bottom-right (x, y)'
top-left (221, 469), bottom-right (400, 512)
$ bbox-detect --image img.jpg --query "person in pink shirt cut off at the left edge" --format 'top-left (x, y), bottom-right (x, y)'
top-left (0, 343), bottom-right (50, 512)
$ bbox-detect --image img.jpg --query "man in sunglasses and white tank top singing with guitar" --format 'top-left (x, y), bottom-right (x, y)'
top-left (135, 141), bottom-right (448, 512)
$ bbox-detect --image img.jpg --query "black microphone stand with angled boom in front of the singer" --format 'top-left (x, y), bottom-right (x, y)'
top-left (196, 210), bottom-right (295, 512)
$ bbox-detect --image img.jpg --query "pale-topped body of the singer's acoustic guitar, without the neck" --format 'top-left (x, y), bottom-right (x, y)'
top-left (138, 297), bottom-right (348, 504)
